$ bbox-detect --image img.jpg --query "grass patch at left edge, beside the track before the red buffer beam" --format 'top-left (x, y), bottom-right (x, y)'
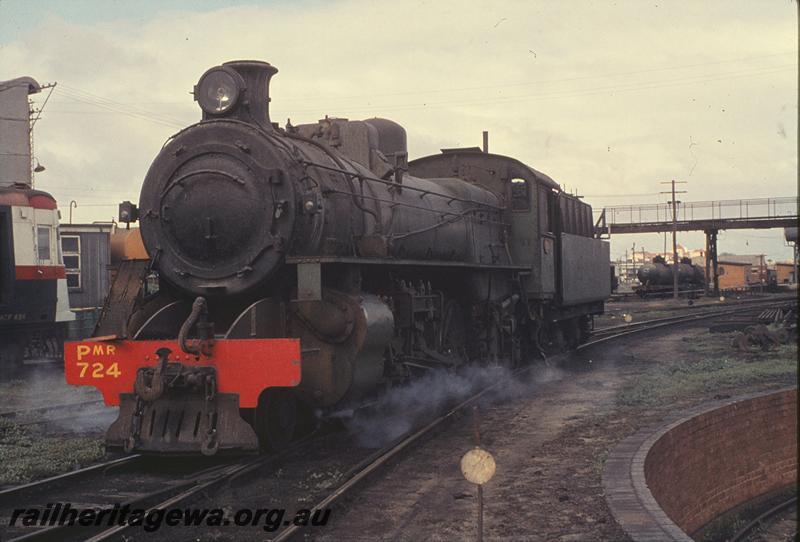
top-left (0, 419), bottom-right (105, 485)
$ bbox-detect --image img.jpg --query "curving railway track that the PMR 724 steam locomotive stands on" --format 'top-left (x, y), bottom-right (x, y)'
top-left (0, 300), bottom-right (788, 542)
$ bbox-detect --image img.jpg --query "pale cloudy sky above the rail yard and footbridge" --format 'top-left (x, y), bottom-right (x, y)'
top-left (0, 0), bottom-right (798, 260)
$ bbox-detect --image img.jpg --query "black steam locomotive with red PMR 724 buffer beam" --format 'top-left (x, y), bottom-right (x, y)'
top-left (65, 61), bottom-right (610, 454)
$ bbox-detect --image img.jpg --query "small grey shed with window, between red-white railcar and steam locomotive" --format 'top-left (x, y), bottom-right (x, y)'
top-left (60, 223), bottom-right (113, 339)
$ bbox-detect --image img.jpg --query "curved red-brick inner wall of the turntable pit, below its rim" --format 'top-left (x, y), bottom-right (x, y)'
top-left (644, 389), bottom-right (797, 533)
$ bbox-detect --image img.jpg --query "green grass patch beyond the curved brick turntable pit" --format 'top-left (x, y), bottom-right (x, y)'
top-left (617, 333), bottom-right (797, 406)
